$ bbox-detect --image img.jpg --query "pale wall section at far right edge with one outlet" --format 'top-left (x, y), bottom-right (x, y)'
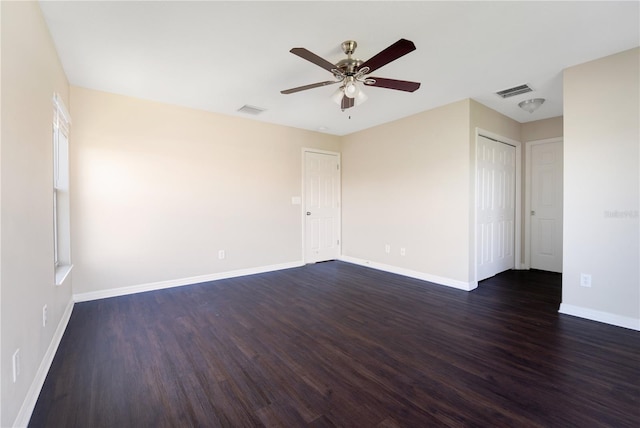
top-left (561, 48), bottom-right (640, 329)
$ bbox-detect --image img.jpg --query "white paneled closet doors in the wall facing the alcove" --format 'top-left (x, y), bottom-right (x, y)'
top-left (476, 136), bottom-right (516, 281)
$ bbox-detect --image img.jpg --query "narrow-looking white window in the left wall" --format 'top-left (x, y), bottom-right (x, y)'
top-left (53, 95), bottom-right (73, 285)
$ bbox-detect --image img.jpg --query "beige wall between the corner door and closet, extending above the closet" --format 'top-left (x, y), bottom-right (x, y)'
top-left (342, 100), bottom-right (520, 288)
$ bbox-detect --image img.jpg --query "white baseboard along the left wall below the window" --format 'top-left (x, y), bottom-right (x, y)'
top-left (13, 299), bottom-right (74, 427)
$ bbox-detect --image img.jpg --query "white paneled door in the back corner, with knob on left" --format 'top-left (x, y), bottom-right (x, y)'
top-left (304, 151), bottom-right (340, 263)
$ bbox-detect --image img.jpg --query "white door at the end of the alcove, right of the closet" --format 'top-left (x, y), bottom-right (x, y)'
top-left (530, 141), bottom-right (563, 272)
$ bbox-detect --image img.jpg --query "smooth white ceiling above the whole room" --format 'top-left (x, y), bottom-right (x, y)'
top-left (41, 1), bottom-right (640, 135)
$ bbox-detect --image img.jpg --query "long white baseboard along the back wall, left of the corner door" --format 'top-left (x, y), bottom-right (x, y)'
top-left (73, 261), bottom-right (304, 302)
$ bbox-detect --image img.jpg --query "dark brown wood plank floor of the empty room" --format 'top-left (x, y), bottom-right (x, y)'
top-left (30, 262), bottom-right (640, 428)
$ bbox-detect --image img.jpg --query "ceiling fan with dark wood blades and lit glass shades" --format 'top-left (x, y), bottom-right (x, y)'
top-left (280, 39), bottom-right (420, 110)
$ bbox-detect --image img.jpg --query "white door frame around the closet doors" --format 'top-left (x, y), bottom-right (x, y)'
top-left (469, 128), bottom-right (522, 290)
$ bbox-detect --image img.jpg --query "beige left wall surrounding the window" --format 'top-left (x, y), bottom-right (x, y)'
top-left (0, 1), bottom-right (71, 427)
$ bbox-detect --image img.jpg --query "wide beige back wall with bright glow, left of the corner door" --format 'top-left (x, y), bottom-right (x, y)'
top-left (71, 87), bottom-right (340, 293)
